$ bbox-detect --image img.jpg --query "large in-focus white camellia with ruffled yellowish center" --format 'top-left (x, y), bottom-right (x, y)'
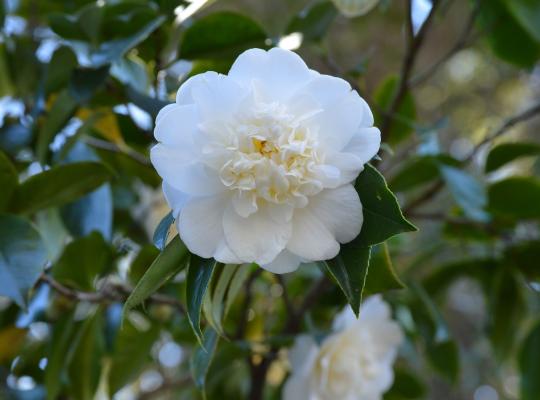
top-left (150, 48), bottom-right (380, 273)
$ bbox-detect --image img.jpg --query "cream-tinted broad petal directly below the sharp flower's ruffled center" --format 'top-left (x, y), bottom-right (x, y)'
top-left (223, 206), bottom-right (291, 265)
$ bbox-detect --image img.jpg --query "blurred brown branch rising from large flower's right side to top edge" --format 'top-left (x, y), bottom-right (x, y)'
top-left (381, 0), bottom-right (440, 141)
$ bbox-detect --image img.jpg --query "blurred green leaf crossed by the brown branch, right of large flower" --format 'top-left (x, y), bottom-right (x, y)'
top-left (374, 76), bottom-right (416, 145)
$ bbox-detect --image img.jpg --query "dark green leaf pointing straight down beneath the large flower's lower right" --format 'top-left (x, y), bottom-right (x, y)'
top-left (323, 242), bottom-right (370, 316)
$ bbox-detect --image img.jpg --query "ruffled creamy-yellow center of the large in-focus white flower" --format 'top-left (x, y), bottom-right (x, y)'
top-left (216, 103), bottom-right (327, 209)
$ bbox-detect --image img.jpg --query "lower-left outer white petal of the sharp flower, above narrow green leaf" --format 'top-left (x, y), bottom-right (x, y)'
top-left (177, 196), bottom-right (229, 258)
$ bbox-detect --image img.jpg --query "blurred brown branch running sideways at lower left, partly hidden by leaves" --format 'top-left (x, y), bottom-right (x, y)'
top-left (39, 273), bottom-right (185, 313)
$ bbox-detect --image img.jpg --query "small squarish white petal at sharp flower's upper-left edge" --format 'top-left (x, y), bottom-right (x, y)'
top-left (154, 104), bottom-right (198, 148)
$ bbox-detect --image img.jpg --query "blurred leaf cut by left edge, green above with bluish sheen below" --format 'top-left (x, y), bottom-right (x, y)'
top-left (0, 214), bottom-right (47, 307)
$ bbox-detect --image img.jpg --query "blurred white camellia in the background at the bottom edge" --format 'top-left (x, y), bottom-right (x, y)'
top-left (283, 296), bottom-right (403, 400)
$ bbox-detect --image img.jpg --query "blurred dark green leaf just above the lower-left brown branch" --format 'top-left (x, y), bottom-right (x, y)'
top-left (52, 232), bottom-right (112, 291)
